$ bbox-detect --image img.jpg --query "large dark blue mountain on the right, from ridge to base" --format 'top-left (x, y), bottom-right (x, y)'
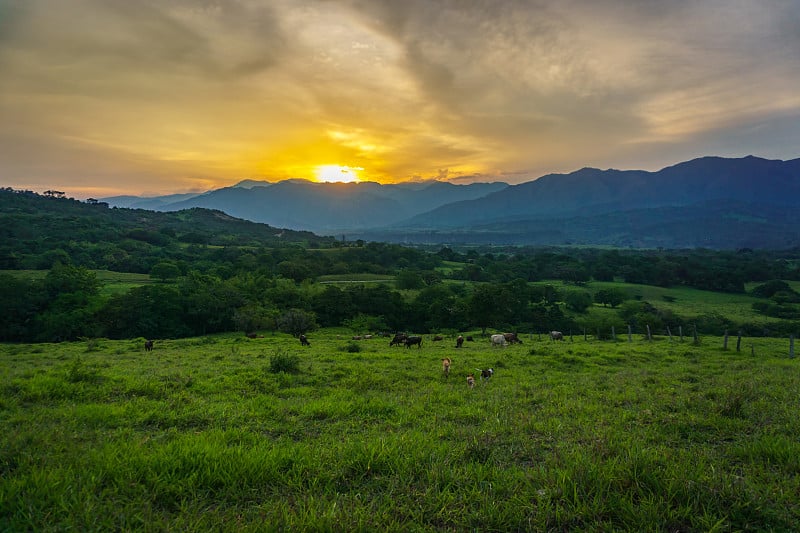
top-left (352, 156), bottom-right (800, 248)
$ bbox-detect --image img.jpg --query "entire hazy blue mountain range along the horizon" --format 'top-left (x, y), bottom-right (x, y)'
top-left (103, 156), bottom-right (800, 249)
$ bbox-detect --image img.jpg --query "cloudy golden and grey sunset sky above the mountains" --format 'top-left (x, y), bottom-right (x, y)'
top-left (0, 0), bottom-right (800, 198)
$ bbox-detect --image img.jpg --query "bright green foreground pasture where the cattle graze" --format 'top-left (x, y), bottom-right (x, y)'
top-left (0, 330), bottom-right (800, 531)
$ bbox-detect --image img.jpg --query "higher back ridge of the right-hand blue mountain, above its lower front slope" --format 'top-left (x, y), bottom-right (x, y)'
top-left (402, 156), bottom-right (800, 228)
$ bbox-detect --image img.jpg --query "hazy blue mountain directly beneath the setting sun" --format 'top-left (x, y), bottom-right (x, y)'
top-left (102, 180), bottom-right (508, 234)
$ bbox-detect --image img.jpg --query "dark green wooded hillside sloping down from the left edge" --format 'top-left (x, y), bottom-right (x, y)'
top-left (0, 189), bottom-right (332, 272)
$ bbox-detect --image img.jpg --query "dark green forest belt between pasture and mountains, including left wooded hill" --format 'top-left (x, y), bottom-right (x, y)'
top-left (0, 189), bottom-right (800, 342)
